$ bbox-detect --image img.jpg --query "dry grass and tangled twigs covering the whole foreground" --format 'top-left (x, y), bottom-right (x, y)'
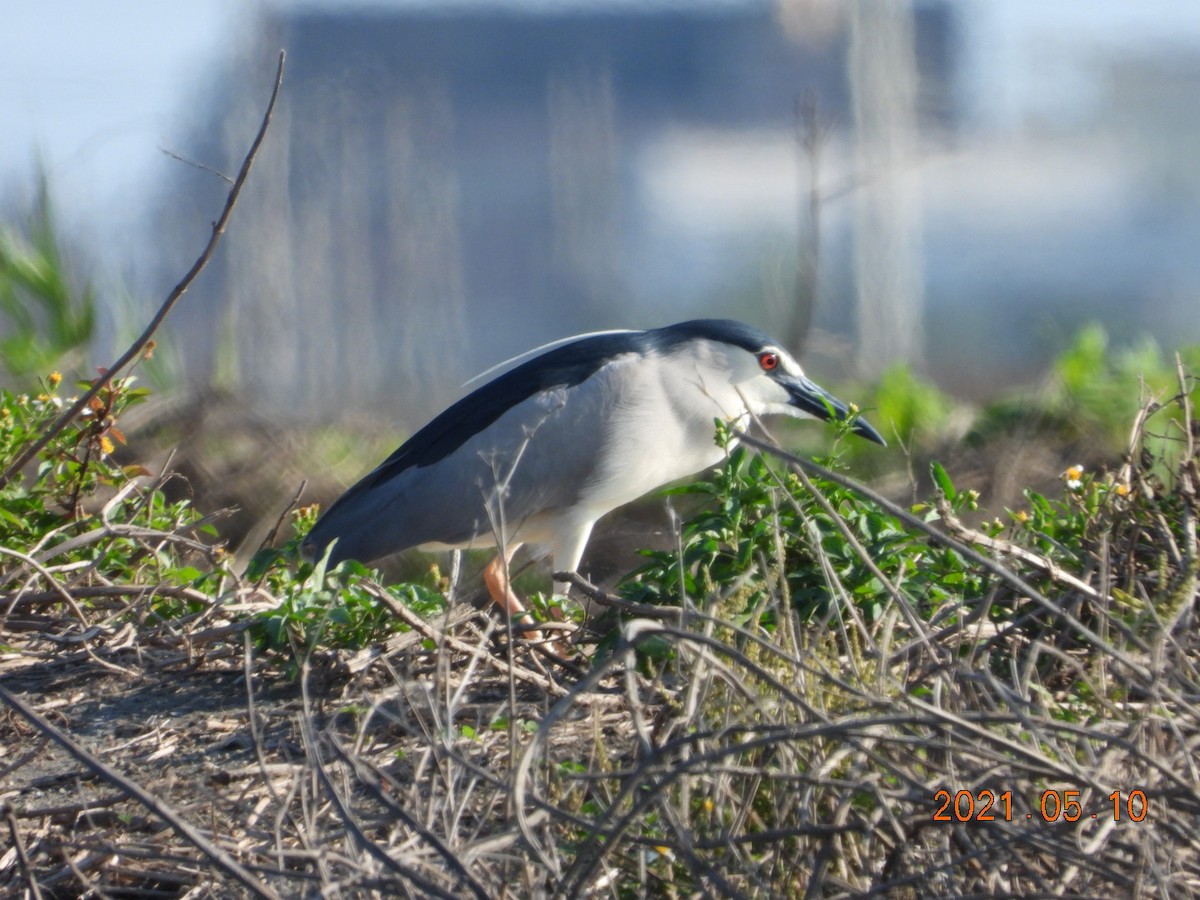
top-left (0, 393), bottom-right (1200, 898)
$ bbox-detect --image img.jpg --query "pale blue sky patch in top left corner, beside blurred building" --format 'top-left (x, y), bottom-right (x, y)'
top-left (0, 0), bottom-right (238, 244)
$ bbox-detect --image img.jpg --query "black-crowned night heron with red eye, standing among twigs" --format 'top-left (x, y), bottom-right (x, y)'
top-left (305, 319), bottom-right (884, 616)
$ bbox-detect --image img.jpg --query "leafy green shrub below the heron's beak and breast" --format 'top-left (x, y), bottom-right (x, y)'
top-left (620, 427), bottom-right (985, 630)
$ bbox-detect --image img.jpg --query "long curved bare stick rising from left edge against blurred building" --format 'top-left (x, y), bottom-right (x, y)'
top-left (0, 50), bottom-right (284, 488)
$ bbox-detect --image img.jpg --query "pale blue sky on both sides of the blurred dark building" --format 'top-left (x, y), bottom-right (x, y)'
top-left (9, 0), bottom-right (1200, 278)
